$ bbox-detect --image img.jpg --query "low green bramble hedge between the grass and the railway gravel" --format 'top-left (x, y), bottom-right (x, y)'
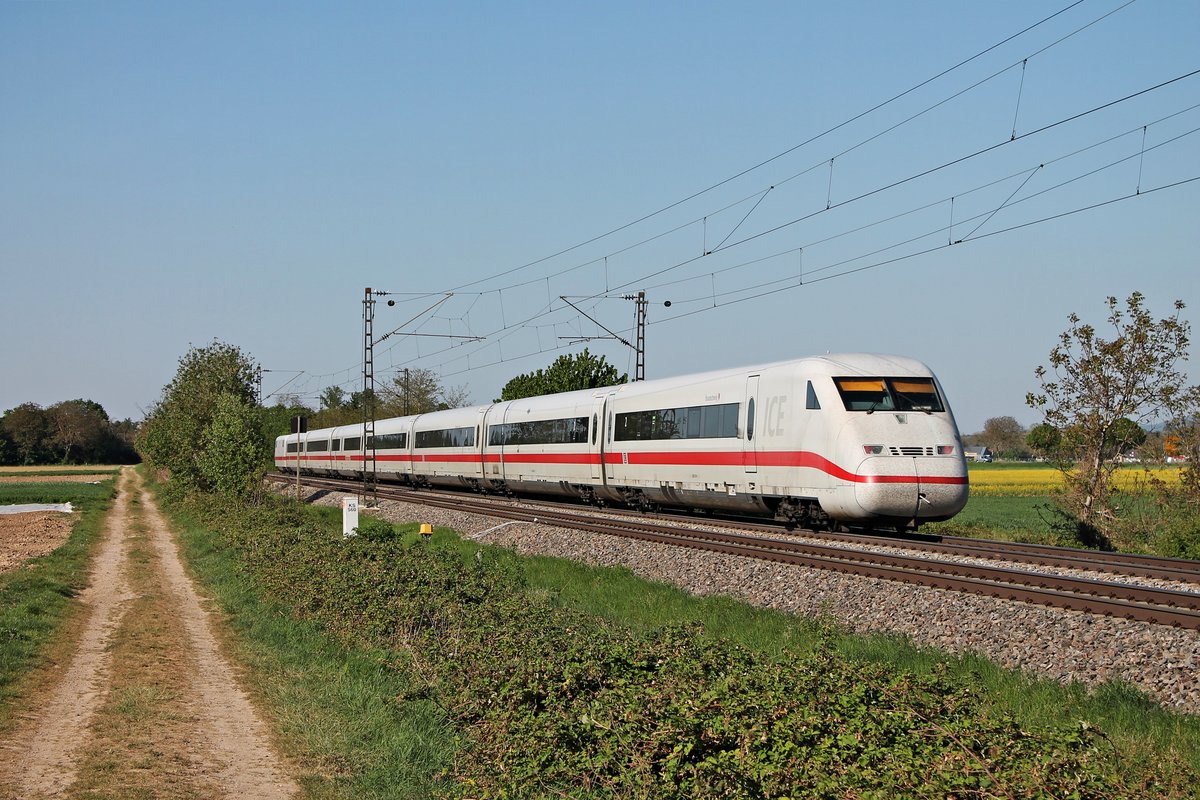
top-left (174, 499), bottom-right (1196, 799)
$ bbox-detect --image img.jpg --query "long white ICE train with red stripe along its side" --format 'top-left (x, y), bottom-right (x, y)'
top-left (275, 353), bottom-right (967, 528)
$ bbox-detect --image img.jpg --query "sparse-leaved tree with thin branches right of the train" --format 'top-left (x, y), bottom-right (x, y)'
top-left (1026, 291), bottom-right (1198, 545)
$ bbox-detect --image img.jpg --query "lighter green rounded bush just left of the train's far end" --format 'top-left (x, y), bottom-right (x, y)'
top-left (197, 392), bottom-right (271, 497)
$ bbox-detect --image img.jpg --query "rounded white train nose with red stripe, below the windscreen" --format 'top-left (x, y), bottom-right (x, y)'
top-left (854, 457), bottom-right (967, 522)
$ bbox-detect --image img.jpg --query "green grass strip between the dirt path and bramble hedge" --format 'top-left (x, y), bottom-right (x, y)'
top-left (164, 489), bottom-right (452, 799)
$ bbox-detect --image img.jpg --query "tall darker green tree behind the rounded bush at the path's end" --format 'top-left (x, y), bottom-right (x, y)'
top-left (138, 341), bottom-right (258, 491)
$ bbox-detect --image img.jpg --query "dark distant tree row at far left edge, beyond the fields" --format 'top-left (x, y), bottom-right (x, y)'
top-left (0, 399), bottom-right (139, 467)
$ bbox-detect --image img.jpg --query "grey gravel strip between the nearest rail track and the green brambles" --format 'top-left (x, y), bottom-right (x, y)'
top-left (300, 484), bottom-right (1200, 714)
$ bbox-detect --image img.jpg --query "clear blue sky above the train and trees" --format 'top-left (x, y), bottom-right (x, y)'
top-left (0, 0), bottom-right (1200, 432)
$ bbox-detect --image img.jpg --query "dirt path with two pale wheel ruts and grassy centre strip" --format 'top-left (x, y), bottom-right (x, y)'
top-left (0, 470), bottom-right (298, 800)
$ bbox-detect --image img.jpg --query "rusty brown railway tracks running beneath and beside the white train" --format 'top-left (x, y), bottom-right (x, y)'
top-left (272, 475), bottom-right (1200, 630)
